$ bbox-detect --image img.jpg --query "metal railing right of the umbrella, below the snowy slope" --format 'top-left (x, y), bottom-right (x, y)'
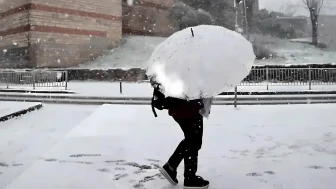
top-left (240, 67), bottom-right (336, 89)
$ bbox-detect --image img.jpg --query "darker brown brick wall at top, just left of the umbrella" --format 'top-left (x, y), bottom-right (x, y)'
top-left (122, 0), bottom-right (177, 36)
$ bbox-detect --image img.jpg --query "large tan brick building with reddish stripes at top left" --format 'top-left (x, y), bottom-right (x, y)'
top-left (0, 0), bottom-right (122, 67)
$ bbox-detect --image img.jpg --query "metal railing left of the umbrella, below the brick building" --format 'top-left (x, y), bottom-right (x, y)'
top-left (0, 70), bottom-right (68, 90)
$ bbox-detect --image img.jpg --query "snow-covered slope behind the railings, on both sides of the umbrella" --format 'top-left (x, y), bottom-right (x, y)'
top-left (74, 36), bottom-right (336, 69)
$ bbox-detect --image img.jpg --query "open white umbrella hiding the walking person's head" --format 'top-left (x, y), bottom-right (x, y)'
top-left (146, 25), bottom-right (255, 100)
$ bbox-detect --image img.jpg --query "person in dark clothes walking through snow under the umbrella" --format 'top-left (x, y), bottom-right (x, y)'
top-left (160, 98), bottom-right (213, 189)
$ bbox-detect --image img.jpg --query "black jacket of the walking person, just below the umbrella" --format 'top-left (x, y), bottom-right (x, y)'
top-left (168, 100), bottom-right (203, 119)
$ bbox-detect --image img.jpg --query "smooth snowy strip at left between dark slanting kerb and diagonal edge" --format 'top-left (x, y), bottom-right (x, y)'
top-left (0, 102), bottom-right (97, 188)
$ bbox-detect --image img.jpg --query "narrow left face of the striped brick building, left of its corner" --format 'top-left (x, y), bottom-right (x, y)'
top-left (0, 0), bottom-right (28, 68)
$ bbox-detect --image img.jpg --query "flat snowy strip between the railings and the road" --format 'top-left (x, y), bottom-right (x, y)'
top-left (0, 81), bottom-right (336, 97)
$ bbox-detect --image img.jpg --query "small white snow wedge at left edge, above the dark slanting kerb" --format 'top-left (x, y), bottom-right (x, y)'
top-left (0, 101), bottom-right (41, 117)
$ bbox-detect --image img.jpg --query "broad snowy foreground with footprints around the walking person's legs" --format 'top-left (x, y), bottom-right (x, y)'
top-left (0, 105), bottom-right (336, 189)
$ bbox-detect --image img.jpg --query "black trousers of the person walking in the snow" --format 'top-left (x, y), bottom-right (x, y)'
top-left (168, 117), bottom-right (203, 179)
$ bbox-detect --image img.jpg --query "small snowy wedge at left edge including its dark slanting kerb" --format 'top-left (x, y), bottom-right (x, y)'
top-left (0, 101), bottom-right (42, 122)
